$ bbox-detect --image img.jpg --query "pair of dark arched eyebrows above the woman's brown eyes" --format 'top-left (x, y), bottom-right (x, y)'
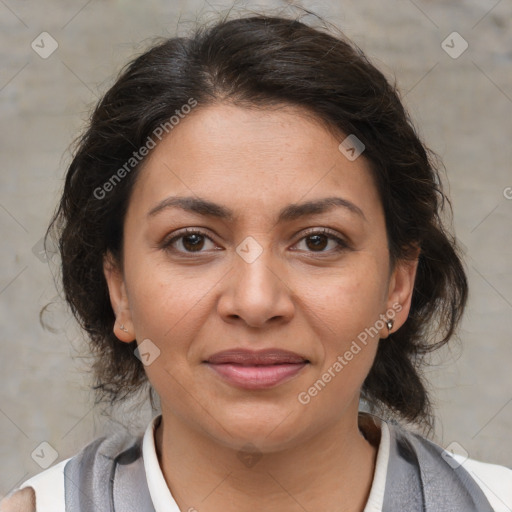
top-left (148, 196), bottom-right (367, 222)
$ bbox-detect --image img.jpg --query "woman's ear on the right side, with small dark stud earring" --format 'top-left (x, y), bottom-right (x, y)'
top-left (383, 247), bottom-right (421, 338)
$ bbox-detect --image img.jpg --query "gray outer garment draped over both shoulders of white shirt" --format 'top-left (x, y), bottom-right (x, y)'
top-left (60, 424), bottom-right (493, 512)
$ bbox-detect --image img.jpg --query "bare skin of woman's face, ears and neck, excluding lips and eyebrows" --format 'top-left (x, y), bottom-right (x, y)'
top-left (104, 104), bottom-right (417, 512)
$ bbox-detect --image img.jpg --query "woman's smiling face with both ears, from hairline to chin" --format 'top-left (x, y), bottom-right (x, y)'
top-left (105, 105), bottom-right (416, 451)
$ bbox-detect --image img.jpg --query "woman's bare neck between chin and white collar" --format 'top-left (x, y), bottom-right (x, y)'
top-left (155, 409), bottom-right (380, 512)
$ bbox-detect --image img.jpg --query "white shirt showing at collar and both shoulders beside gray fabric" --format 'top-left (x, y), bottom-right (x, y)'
top-left (20, 416), bottom-right (512, 512)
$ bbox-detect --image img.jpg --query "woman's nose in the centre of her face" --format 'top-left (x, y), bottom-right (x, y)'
top-left (217, 243), bottom-right (295, 328)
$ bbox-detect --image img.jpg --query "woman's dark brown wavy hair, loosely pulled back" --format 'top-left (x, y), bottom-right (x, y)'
top-left (46, 9), bottom-right (468, 425)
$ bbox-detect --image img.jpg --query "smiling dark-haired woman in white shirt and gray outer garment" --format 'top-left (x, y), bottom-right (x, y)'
top-left (4, 9), bottom-right (512, 512)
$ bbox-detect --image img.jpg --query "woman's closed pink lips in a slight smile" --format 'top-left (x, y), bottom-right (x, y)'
top-left (203, 349), bottom-right (310, 390)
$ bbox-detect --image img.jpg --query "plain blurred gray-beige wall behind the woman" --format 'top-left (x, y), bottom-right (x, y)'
top-left (0, 0), bottom-right (512, 495)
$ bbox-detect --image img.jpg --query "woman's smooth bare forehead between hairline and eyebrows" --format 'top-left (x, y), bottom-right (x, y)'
top-left (130, 104), bottom-right (379, 222)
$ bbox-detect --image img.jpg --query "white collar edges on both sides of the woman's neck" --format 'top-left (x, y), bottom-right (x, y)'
top-left (142, 415), bottom-right (390, 512)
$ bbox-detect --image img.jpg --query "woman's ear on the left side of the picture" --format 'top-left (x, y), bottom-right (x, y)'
top-left (103, 252), bottom-right (135, 343)
